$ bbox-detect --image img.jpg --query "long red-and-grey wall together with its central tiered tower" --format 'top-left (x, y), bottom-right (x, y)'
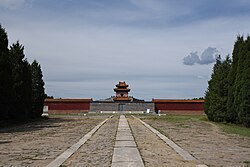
top-left (44, 81), bottom-right (204, 115)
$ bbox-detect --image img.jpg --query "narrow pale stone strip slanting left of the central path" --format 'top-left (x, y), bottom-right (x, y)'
top-left (46, 116), bottom-right (112, 167)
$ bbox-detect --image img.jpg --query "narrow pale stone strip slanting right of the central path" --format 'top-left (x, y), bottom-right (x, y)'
top-left (132, 116), bottom-right (207, 167)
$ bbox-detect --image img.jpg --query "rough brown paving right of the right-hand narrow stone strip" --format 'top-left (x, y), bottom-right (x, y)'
top-left (140, 116), bottom-right (250, 167)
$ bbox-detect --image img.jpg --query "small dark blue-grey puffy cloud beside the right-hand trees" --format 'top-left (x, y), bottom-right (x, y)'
top-left (183, 47), bottom-right (218, 66)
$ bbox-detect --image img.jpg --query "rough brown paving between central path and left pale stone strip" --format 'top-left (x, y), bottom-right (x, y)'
top-left (62, 116), bottom-right (119, 167)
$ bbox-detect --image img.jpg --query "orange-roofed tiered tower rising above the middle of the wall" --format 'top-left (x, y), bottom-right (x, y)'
top-left (114, 81), bottom-right (131, 101)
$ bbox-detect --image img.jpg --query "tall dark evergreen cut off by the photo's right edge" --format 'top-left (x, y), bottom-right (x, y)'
top-left (234, 36), bottom-right (250, 127)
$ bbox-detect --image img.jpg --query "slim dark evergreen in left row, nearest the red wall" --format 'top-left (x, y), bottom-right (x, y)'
top-left (31, 60), bottom-right (45, 117)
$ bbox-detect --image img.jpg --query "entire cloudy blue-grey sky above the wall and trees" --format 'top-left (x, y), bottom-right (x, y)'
top-left (0, 0), bottom-right (250, 100)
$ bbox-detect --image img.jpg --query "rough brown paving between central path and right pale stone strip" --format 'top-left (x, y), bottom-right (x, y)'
top-left (128, 117), bottom-right (200, 167)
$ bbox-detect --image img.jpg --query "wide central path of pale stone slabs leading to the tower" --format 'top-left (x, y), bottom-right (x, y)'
top-left (111, 115), bottom-right (144, 167)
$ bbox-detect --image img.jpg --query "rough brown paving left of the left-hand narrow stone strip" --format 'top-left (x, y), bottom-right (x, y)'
top-left (0, 116), bottom-right (107, 167)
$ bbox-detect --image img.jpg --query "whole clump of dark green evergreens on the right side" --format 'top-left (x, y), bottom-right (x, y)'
top-left (205, 35), bottom-right (250, 127)
